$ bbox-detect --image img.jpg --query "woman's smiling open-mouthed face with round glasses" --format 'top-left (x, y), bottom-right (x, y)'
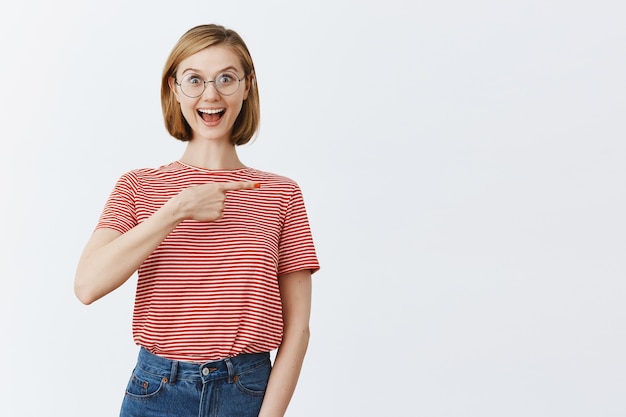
top-left (170, 45), bottom-right (250, 142)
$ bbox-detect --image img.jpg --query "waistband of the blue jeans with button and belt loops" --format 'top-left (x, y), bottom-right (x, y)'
top-left (137, 347), bottom-right (270, 384)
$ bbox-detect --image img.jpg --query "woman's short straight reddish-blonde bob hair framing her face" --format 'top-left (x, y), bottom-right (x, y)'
top-left (161, 24), bottom-right (261, 145)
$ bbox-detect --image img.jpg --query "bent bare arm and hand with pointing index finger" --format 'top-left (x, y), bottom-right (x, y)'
top-left (74, 182), bottom-right (258, 304)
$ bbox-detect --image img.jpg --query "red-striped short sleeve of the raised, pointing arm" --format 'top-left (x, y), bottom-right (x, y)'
top-left (96, 172), bottom-right (138, 233)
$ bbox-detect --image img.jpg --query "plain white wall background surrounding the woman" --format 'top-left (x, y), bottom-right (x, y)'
top-left (0, 0), bottom-right (626, 417)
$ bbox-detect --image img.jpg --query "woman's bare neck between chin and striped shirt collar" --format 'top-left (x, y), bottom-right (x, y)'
top-left (180, 140), bottom-right (245, 170)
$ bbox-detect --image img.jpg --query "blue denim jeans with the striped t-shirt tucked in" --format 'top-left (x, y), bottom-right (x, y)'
top-left (120, 348), bottom-right (272, 417)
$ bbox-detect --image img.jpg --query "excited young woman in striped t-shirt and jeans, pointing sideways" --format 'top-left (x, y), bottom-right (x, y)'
top-left (75, 25), bottom-right (319, 417)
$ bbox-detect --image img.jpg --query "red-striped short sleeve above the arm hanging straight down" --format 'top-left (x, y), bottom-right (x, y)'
top-left (278, 185), bottom-right (320, 275)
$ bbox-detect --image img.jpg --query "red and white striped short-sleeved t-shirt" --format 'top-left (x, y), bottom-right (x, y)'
top-left (97, 161), bottom-right (319, 362)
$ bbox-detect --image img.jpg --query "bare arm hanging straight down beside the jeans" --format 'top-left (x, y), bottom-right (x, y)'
top-left (259, 270), bottom-right (312, 417)
